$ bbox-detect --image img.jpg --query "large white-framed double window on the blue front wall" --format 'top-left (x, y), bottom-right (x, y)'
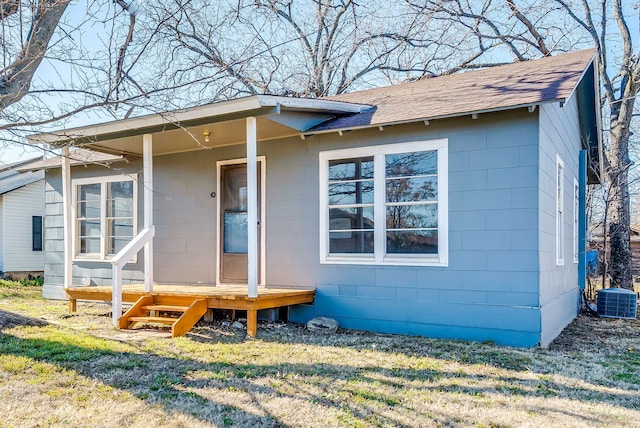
top-left (320, 139), bottom-right (448, 266)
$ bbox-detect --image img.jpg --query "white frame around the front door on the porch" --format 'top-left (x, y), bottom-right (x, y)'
top-left (216, 156), bottom-right (267, 287)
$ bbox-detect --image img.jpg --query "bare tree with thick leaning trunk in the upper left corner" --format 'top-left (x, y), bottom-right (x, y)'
top-left (0, 0), bottom-right (159, 154)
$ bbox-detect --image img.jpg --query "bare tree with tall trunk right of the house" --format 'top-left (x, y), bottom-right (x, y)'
top-left (409, 0), bottom-right (640, 288)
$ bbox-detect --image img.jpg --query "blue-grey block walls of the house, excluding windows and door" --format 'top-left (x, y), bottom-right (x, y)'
top-left (45, 102), bottom-right (580, 346)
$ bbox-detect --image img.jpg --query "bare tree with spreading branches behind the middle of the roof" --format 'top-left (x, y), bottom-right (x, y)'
top-left (144, 0), bottom-right (504, 103)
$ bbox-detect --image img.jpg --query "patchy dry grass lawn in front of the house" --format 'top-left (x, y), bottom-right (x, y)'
top-left (0, 286), bottom-right (640, 427)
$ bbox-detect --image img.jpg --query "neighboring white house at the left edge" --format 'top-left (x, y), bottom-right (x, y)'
top-left (0, 158), bottom-right (44, 278)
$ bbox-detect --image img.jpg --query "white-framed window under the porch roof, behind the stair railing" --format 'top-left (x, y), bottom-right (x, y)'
top-left (74, 176), bottom-right (137, 260)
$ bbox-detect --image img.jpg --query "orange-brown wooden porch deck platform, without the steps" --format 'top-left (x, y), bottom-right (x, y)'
top-left (66, 284), bottom-right (315, 337)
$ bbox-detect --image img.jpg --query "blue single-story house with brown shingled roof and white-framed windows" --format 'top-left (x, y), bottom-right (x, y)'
top-left (30, 50), bottom-right (602, 346)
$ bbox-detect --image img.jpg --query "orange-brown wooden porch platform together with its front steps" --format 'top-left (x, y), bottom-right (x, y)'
top-left (66, 284), bottom-right (315, 337)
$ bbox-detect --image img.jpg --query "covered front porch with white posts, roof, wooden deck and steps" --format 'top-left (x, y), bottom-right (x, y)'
top-left (25, 95), bottom-right (362, 336)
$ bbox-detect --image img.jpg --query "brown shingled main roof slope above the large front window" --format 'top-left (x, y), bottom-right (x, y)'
top-left (308, 49), bottom-right (595, 133)
